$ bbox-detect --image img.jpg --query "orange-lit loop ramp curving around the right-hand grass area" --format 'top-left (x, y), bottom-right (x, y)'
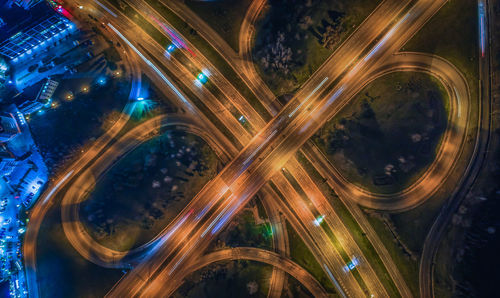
top-left (303, 53), bottom-right (471, 210)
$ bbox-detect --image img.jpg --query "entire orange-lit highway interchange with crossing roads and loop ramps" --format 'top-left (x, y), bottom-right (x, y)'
top-left (24, 0), bottom-right (492, 297)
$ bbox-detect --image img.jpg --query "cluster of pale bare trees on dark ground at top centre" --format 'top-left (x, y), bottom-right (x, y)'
top-left (256, 0), bottom-right (344, 78)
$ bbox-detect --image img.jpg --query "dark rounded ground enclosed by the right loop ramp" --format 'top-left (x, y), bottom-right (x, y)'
top-left (314, 72), bottom-right (448, 193)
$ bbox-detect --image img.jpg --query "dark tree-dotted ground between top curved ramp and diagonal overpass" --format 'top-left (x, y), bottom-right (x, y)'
top-left (253, 0), bottom-right (379, 96)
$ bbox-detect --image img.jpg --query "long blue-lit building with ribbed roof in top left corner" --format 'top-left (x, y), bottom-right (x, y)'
top-left (0, 1), bottom-right (78, 91)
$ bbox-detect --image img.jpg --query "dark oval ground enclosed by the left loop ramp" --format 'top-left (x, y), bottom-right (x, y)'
top-left (80, 131), bottom-right (218, 250)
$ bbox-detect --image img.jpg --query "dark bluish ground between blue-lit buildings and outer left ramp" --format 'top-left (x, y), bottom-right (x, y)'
top-left (29, 74), bottom-right (130, 170)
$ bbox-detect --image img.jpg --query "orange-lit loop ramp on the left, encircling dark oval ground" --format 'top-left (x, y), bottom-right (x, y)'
top-left (61, 115), bottom-right (228, 268)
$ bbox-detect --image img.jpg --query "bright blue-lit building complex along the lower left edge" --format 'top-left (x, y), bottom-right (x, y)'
top-left (0, 105), bottom-right (48, 297)
